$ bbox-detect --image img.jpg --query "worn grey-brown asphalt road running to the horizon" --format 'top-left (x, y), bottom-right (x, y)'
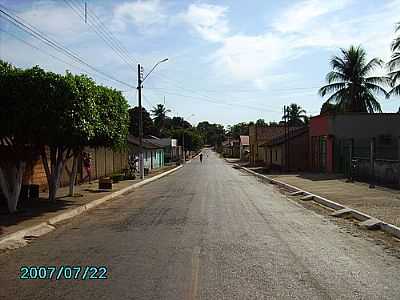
top-left (0, 150), bottom-right (400, 300)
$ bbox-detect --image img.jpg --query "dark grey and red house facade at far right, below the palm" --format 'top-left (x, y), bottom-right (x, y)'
top-left (309, 113), bottom-right (400, 186)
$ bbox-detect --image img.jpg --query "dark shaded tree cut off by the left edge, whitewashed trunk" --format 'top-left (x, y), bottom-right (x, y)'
top-left (0, 60), bottom-right (40, 213)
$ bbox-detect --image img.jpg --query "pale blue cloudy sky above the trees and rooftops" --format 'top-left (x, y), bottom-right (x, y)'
top-left (0, 0), bottom-right (400, 125)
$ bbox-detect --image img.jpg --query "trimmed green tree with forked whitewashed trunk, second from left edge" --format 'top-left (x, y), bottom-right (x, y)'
top-left (1, 59), bottom-right (128, 207)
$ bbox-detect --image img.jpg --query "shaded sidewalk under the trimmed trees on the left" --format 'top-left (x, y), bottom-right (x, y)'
top-left (0, 166), bottom-right (175, 239)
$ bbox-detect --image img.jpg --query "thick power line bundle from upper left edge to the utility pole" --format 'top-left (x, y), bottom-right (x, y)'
top-left (0, 4), bottom-right (134, 88)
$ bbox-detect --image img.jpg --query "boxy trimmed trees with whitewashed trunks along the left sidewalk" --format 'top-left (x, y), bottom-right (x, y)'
top-left (0, 61), bottom-right (129, 212)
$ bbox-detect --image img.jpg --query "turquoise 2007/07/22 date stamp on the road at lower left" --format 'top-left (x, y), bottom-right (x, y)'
top-left (19, 266), bottom-right (108, 280)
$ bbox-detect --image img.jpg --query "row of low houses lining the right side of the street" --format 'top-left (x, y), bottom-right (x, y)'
top-left (227, 113), bottom-right (400, 186)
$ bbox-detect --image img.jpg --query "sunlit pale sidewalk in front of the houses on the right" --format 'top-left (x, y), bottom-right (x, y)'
top-left (265, 173), bottom-right (400, 226)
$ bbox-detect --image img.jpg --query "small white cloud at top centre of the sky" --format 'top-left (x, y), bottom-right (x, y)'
top-left (182, 4), bottom-right (229, 42)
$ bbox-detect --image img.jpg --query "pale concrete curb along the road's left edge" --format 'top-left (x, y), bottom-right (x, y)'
top-left (0, 165), bottom-right (183, 250)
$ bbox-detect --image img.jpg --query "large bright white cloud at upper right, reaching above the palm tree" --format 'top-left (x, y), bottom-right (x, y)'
top-left (212, 0), bottom-right (400, 88)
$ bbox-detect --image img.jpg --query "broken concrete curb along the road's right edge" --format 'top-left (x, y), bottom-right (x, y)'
top-left (236, 165), bottom-right (400, 238)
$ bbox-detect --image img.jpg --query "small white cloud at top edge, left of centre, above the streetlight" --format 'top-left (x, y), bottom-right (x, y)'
top-left (114, 0), bottom-right (167, 31)
